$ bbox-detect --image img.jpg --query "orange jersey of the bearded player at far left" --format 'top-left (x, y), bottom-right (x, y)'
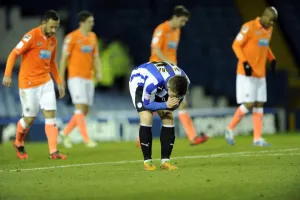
top-left (14, 27), bottom-right (57, 88)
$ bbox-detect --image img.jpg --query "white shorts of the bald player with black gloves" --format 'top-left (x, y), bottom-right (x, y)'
top-left (236, 74), bottom-right (267, 104)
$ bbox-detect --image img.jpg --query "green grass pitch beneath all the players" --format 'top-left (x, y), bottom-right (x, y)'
top-left (0, 133), bottom-right (300, 200)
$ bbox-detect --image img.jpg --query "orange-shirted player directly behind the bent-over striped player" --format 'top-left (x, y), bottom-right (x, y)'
top-left (150, 6), bottom-right (209, 145)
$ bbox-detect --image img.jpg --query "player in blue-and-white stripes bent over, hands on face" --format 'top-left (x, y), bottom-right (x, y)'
top-left (129, 62), bottom-right (189, 171)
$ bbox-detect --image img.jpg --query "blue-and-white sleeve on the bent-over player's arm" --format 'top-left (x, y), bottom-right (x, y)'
top-left (142, 78), bottom-right (168, 111)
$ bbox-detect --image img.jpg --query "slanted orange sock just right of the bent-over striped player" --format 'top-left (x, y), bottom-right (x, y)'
top-left (178, 111), bottom-right (197, 141)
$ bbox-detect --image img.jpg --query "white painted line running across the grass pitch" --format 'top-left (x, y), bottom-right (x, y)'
top-left (0, 148), bottom-right (300, 173)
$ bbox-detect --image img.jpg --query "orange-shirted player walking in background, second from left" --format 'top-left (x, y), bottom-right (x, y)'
top-left (60, 11), bottom-right (101, 148)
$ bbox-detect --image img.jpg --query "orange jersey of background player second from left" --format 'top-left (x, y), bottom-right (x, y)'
top-left (63, 29), bottom-right (99, 79)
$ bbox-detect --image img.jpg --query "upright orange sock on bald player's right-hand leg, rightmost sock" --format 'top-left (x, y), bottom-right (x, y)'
top-left (252, 108), bottom-right (264, 141)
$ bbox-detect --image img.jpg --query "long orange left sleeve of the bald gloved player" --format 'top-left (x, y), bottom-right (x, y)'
top-left (232, 23), bottom-right (251, 62)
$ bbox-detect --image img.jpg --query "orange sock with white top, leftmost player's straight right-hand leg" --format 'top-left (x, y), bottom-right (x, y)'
top-left (45, 118), bottom-right (58, 154)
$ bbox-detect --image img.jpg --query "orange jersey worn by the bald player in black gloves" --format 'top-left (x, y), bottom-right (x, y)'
top-left (232, 18), bottom-right (275, 77)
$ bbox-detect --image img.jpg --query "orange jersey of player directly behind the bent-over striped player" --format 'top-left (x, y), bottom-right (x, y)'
top-left (150, 21), bottom-right (180, 64)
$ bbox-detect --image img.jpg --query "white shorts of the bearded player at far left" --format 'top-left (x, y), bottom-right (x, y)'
top-left (19, 80), bottom-right (56, 117)
